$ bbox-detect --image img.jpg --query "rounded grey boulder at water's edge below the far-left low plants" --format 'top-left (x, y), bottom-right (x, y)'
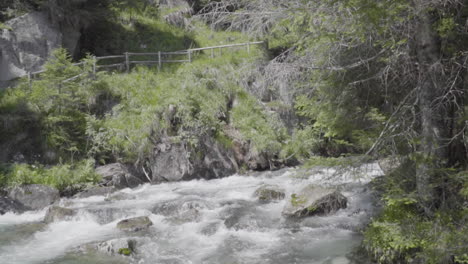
top-left (8, 184), bottom-right (60, 210)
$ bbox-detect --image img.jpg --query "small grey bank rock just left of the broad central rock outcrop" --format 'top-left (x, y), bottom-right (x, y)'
top-left (96, 163), bottom-right (143, 189)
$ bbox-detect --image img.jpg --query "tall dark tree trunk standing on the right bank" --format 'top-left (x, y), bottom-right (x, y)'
top-left (414, 0), bottom-right (447, 214)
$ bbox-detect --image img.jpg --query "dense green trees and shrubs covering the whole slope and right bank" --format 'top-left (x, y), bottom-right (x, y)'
top-left (0, 0), bottom-right (468, 263)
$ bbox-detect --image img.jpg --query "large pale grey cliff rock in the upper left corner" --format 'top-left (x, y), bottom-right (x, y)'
top-left (0, 12), bottom-right (81, 81)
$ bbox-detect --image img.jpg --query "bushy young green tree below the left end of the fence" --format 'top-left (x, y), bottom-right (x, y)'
top-left (26, 49), bottom-right (115, 161)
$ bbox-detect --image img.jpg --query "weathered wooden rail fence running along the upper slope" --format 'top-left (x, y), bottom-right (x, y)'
top-left (27, 41), bottom-right (266, 86)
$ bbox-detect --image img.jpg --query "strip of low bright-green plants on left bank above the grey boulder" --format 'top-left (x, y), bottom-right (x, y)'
top-left (0, 159), bottom-right (100, 190)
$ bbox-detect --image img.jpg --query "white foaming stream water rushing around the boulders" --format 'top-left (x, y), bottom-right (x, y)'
top-left (0, 164), bottom-right (382, 264)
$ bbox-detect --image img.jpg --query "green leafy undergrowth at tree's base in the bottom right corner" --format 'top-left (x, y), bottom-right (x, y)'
top-left (364, 163), bottom-right (468, 264)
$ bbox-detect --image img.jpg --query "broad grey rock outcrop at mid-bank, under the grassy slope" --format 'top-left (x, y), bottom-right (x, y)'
top-left (151, 136), bottom-right (238, 183)
